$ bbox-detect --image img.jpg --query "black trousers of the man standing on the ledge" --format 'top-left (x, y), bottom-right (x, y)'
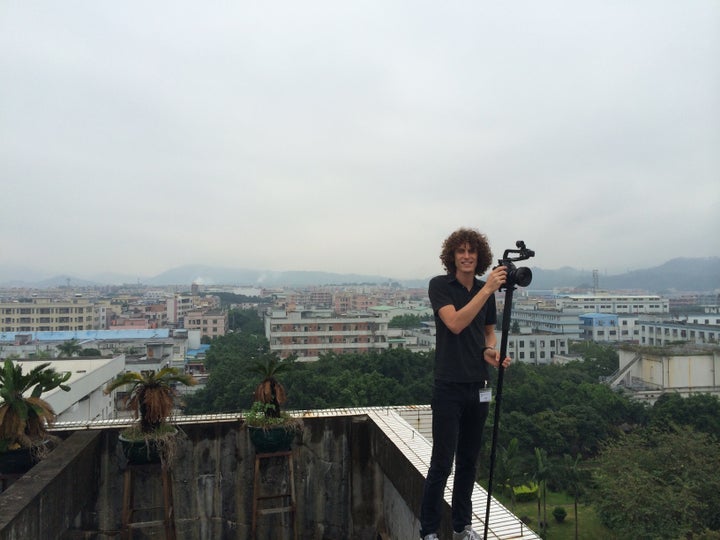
top-left (420, 381), bottom-right (490, 537)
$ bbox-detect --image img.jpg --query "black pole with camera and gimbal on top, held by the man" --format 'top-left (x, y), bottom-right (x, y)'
top-left (483, 240), bottom-right (535, 540)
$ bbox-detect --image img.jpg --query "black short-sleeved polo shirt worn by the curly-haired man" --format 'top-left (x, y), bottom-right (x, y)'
top-left (428, 274), bottom-right (497, 382)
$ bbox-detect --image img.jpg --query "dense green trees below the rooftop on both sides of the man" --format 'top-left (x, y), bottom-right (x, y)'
top-left (187, 312), bottom-right (720, 540)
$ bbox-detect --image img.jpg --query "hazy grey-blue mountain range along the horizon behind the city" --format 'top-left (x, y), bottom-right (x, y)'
top-left (0, 257), bottom-right (720, 293)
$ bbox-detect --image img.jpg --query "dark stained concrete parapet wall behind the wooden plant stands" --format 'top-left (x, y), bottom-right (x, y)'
top-left (0, 415), bottom-right (422, 540)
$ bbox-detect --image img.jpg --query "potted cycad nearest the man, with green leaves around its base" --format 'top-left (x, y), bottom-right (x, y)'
top-left (244, 357), bottom-right (303, 453)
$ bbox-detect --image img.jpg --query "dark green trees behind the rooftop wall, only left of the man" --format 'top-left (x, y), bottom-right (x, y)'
top-left (186, 332), bottom-right (432, 414)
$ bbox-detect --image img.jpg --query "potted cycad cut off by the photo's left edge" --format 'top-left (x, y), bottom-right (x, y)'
top-left (0, 359), bottom-right (71, 474)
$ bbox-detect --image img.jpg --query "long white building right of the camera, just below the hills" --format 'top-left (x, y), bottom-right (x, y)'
top-left (555, 294), bottom-right (670, 315)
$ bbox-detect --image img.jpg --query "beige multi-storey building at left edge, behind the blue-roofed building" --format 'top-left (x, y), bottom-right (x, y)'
top-left (0, 296), bottom-right (95, 332)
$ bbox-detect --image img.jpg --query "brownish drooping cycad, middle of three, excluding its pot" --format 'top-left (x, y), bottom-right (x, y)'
top-left (105, 367), bottom-right (197, 434)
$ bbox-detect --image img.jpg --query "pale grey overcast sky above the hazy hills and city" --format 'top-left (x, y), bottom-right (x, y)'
top-left (0, 0), bottom-right (720, 279)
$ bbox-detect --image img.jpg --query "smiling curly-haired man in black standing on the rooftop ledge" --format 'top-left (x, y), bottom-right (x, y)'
top-left (420, 229), bottom-right (510, 540)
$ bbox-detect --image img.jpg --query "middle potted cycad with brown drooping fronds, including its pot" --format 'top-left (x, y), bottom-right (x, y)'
top-left (105, 367), bottom-right (197, 464)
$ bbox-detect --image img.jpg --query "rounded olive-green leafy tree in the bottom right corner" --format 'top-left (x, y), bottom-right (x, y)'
top-left (593, 427), bottom-right (720, 540)
